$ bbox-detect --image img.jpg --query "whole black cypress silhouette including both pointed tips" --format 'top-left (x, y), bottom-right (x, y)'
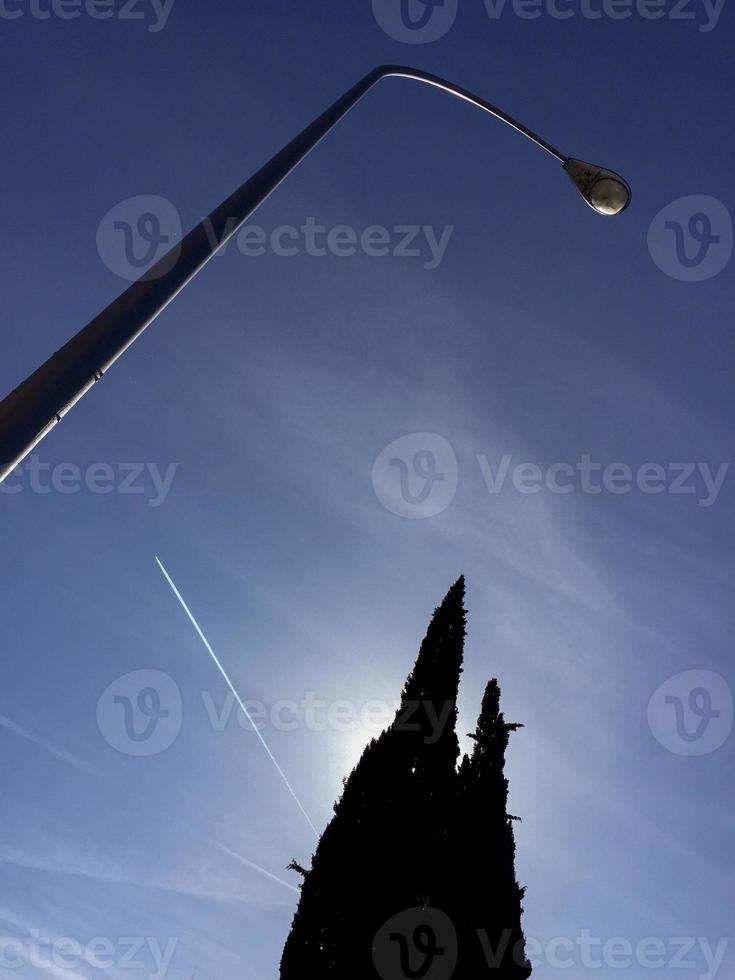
top-left (281, 578), bottom-right (529, 980)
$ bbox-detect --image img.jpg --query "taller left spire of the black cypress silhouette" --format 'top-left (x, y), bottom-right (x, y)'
top-left (281, 578), bottom-right (466, 980)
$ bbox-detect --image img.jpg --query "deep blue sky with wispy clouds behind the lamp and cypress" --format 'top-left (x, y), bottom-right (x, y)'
top-left (0, 0), bottom-right (735, 980)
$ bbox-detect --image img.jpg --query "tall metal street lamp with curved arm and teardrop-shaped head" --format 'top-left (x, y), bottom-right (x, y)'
top-left (0, 65), bottom-right (630, 482)
